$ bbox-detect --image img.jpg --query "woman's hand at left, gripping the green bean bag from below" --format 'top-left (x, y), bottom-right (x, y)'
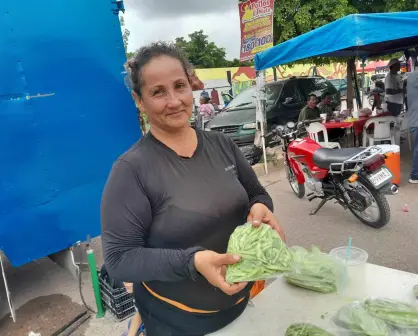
top-left (194, 251), bottom-right (247, 295)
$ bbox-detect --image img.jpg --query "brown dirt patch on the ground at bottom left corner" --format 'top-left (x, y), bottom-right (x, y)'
top-left (0, 294), bottom-right (85, 336)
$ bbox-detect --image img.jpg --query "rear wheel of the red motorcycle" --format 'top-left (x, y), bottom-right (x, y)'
top-left (348, 178), bottom-right (390, 229)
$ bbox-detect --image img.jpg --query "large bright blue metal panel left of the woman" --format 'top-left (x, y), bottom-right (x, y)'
top-left (0, 0), bottom-right (140, 266)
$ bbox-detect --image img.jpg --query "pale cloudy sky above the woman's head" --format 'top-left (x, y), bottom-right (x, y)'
top-left (124, 0), bottom-right (240, 60)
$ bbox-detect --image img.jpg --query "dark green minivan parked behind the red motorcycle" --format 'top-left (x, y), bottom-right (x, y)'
top-left (205, 77), bottom-right (341, 164)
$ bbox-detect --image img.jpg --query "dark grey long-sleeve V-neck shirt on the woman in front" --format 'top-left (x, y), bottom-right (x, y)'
top-left (101, 132), bottom-right (273, 310)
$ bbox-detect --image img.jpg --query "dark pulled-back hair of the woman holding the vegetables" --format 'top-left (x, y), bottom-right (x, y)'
top-left (127, 42), bottom-right (193, 97)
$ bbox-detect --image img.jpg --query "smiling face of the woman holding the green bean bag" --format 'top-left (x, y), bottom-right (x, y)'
top-left (138, 56), bottom-right (193, 131)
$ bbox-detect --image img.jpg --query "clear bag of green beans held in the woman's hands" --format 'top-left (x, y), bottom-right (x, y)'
top-left (226, 223), bottom-right (293, 283)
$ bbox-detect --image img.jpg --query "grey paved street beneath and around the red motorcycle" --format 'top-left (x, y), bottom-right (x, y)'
top-left (261, 140), bottom-right (418, 273)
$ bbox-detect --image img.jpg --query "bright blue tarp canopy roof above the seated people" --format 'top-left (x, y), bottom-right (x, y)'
top-left (255, 11), bottom-right (418, 70)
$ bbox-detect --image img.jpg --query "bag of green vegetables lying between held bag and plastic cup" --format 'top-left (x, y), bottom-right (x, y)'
top-left (285, 246), bottom-right (344, 293)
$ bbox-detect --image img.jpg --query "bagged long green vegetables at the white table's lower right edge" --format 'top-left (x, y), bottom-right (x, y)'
top-left (364, 299), bottom-right (418, 328)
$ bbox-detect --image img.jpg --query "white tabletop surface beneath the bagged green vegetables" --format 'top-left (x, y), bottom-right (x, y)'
top-left (211, 264), bottom-right (418, 336)
